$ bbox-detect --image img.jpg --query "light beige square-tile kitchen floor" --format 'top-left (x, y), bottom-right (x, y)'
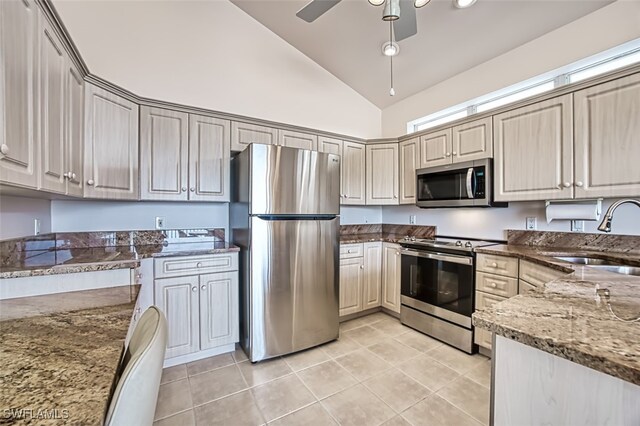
top-left (154, 313), bottom-right (491, 426)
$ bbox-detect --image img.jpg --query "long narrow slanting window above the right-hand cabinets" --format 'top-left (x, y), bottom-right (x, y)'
top-left (407, 39), bottom-right (640, 133)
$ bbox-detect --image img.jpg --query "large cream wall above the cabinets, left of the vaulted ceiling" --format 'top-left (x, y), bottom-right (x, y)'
top-left (54, 0), bottom-right (381, 138)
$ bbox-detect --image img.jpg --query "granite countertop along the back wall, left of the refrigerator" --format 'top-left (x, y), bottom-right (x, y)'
top-left (0, 241), bottom-right (240, 278)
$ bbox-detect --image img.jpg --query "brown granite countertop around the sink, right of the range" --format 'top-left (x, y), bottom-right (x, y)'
top-left (473, 245), bottom-right (640, 385)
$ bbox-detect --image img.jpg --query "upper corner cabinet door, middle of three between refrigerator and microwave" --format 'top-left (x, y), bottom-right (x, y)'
top-left (367, 143), bottom-right (398, 205)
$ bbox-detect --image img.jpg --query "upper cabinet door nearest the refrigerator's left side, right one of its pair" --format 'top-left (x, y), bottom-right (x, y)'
top-left (189, 114), bottom-right (231, 201)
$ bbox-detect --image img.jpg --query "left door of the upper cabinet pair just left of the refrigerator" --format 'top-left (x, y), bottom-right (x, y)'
top-left (140, 106), bottom-right (189, 200)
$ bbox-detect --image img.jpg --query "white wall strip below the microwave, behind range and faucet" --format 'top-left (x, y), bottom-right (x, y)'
top-left (382, 200), bottom-right (640, 239)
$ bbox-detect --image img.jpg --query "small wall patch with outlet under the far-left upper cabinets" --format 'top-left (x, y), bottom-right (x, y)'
top-left (0, 195), bottom-right (51, 240)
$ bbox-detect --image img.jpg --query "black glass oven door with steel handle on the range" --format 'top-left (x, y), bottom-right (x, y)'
top-left (401, 248), bottom-right (474, 329)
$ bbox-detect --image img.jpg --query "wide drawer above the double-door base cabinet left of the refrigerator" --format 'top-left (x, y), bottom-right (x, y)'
top-left (155, 253), bottom-right (238, 278)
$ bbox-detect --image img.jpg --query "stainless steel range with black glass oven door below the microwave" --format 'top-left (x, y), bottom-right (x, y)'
top-left (399, 237), bottom-right (496, 353)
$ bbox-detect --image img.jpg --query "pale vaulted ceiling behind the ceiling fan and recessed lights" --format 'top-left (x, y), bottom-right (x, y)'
top-left (231, 0), bottom-right (613, 108)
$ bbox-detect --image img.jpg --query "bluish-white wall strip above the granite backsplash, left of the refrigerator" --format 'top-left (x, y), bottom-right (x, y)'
top-left (51, 200), bottom-right (229, 232)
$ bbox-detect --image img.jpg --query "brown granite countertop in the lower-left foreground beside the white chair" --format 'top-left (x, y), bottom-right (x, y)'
top-left (0, 286), bottom-right (138, 425)
